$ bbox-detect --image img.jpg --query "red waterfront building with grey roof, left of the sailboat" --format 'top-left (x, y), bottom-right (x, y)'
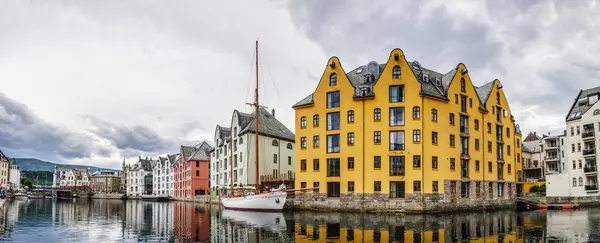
top-left (173, 142), bottom-right (212, 198)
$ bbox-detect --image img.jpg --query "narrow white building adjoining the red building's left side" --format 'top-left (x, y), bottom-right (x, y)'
top-left (152, 154), bottom-right (177, 197)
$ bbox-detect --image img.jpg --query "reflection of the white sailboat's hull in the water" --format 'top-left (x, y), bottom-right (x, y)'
top-left (221, 209), bottom-right (287, 232)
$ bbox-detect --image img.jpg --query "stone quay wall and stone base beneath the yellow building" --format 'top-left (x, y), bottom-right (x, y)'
top-left (290, 181), bottom-right (516, 214)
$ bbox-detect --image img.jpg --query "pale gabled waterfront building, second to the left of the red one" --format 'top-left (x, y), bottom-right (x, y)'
top-left (127, 156), bottom-right (158, 197)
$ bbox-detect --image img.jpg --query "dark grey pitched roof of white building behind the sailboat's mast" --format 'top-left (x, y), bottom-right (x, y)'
top-left (240, 108), bottom-right (295, 142)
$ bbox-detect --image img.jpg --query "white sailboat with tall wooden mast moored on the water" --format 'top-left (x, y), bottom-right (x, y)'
top-left (221, 41), bottom-right (287, 212)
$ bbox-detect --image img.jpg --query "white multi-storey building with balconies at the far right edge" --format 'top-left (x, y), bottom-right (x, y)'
top-left (546, 87), bottom-right (600, 197)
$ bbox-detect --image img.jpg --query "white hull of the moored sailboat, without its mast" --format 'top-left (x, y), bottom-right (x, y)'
top-left (221, 192), bottom-right (287, 212)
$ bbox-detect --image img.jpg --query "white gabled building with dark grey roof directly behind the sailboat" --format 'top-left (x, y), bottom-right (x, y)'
top-left (210, 108), bottom-right (295, 195)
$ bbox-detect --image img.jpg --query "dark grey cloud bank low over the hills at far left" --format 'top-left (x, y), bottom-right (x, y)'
top-left (0, 93), bottom-right (110, 159)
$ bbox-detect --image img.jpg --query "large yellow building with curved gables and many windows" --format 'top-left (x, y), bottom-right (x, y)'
top-left (293, 49), bottom-right (521, 210)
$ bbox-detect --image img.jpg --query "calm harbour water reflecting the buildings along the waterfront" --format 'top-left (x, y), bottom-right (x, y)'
top-left (0, 199), bottom-right (600, 243)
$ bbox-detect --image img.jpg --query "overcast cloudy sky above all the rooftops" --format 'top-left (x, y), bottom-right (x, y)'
top-left (0, 0), bottom-right (600, 168)
